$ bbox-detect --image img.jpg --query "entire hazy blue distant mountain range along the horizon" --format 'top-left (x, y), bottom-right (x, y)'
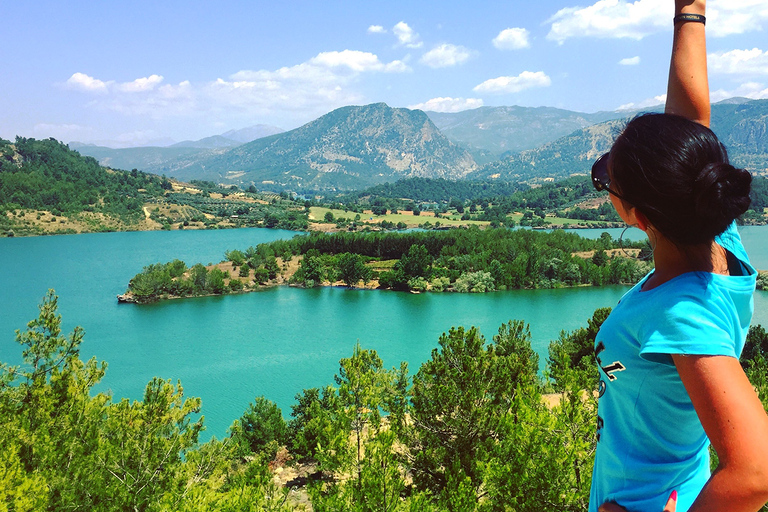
top-left (72, 99), bottom-right (768, 190)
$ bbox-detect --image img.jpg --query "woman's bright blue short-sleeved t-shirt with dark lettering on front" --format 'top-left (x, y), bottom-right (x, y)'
top-left (589, 224), bottom-right (757, 512)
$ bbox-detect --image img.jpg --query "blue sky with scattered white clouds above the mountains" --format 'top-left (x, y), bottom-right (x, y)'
top-left (0, 0), bottom-right (768, 147)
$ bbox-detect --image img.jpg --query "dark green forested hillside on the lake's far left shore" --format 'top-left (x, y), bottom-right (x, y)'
top-left (0, 137), bottom-right (307, 236)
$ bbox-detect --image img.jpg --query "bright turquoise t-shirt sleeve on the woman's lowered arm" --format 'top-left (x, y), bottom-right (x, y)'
top-left (640, 296), bottom-right (738, 364)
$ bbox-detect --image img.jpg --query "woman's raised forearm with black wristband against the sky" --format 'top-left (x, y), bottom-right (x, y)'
top-left (664, 0), bottom-right (710, 126)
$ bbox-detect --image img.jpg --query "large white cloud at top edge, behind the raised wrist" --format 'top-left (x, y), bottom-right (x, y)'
top-left (547, 0), bottom-right (768, 44)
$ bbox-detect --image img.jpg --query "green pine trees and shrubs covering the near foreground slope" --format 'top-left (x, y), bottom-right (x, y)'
top-left (0, 292), bottom-right (768, 512)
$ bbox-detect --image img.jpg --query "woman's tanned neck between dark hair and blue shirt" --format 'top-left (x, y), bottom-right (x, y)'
top-left (643, 230), bottom-right (728, 290)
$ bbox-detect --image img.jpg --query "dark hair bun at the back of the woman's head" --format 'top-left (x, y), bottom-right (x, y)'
top-left (693, 163), bottom-right (752, 227)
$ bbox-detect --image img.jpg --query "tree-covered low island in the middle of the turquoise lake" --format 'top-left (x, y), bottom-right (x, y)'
top-left (121, 227), bottom-right (651, 303)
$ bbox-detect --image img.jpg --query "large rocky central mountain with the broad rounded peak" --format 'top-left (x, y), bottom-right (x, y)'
top-left (161, 103), bottom-right (477, 190)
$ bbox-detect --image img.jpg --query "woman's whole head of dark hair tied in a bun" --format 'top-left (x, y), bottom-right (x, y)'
top-left (611, 114), bottom-right (752, 245)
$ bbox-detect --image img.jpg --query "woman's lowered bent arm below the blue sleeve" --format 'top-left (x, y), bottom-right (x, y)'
top-left (672, 355), bottom-right (768, 512)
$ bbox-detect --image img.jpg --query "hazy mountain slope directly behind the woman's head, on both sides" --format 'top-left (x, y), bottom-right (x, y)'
top-left (467, 100), bottom-right (768, 182)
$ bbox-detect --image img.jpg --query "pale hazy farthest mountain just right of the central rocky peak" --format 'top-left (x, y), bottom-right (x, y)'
top-left (427, 106), bottom-right (628, 160)
